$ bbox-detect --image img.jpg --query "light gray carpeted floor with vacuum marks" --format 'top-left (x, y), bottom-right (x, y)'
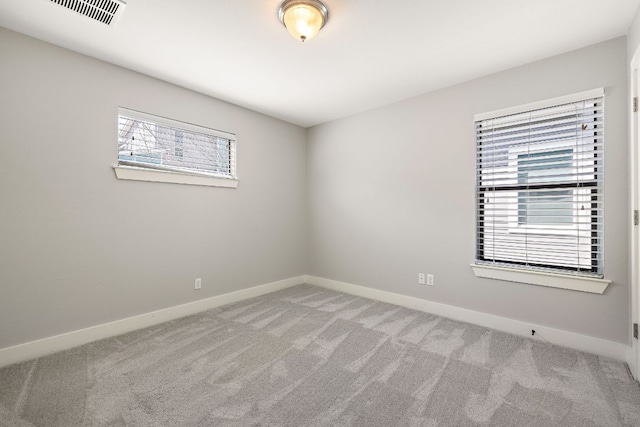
top-left (0, 285), bottom-right (640, 427)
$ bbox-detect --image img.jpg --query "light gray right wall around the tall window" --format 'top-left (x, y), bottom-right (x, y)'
top-left (307, 38), bottom-right (630, 344)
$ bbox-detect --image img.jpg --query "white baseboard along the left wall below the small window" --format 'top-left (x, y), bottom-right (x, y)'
top-left (0, 276), bottom-right (306, 367)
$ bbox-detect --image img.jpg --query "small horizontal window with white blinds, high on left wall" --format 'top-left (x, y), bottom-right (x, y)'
top-left (118, 108), bottom-right (236, 178)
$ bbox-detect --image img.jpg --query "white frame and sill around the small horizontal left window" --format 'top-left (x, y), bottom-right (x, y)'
top-left (113, 107), bottom-right (238, 188)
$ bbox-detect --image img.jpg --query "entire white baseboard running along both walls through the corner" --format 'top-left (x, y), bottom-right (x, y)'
top-left (0, 276), bottom-right (637, 372)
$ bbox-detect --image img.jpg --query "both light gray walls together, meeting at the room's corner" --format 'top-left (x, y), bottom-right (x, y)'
top-left (0, 28), bottom-right (640, 348)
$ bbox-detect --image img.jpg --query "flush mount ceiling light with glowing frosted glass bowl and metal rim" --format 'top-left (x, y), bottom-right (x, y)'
top-left (278, 0), bottom-right (329, 42)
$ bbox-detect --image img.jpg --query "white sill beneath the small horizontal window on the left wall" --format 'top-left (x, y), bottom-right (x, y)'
top-left (113, 165), bottom-right (238, 188)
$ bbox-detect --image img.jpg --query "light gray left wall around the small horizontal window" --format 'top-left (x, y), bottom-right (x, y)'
top-left (0, 28), bottom-right (307, 348)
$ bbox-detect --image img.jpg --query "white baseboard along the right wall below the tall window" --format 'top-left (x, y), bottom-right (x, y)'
top-left (306, 276), bottom-right (630, 362)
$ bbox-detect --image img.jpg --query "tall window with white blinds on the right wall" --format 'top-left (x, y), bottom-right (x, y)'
top-left (475, 89), bottom-right (604, 277)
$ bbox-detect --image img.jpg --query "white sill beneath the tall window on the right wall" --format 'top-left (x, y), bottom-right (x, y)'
top-left (471, 264), bottom-right (611, 294)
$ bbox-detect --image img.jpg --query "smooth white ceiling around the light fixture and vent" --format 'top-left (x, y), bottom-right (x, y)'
top-left (0, 0), bottom-right (640, 127)
